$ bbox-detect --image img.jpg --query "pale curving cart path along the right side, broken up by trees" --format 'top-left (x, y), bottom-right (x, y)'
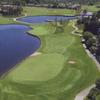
top-left (72, 22), bottom-right (100, 100)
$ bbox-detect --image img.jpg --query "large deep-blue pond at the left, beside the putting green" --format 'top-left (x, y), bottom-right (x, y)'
top-left (0, 24), bottom-right (40, 75)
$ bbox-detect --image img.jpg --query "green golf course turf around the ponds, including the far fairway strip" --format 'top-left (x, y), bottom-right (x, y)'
top-left (0, 7), bottom-right (100, 100)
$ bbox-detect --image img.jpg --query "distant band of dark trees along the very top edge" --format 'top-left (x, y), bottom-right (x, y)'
top-left (0, 0), bottom-right (100, 5)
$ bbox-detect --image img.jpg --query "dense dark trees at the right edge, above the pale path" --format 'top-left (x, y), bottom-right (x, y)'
top-left (77, 11), bottom-right (100, 62)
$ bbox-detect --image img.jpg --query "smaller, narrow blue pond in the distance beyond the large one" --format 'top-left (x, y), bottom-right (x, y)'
top-left (17, 15), bottom-right (76, 24)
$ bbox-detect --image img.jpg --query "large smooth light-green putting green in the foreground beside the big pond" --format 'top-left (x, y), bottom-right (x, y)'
top-left (8, 54), bottom-right (65, 82)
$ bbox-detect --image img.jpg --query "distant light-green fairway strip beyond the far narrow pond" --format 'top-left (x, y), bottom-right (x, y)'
top-left (23, 7), bottom-right (75, 16)
